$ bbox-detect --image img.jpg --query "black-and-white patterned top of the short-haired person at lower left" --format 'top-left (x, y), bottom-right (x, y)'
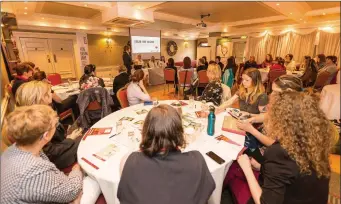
top-left (0, 144), bottom-right (82, 204)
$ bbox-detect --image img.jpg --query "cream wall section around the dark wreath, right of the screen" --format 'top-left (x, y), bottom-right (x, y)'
top-left (161, 39), bottom-right (197, 62)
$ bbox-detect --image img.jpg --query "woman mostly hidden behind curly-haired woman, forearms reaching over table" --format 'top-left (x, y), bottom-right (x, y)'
top-left (237, 75), bottom-right (304, 146)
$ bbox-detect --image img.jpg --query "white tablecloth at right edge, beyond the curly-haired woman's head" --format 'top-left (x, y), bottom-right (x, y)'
top-left (320, 84), bottom-right (340, 120)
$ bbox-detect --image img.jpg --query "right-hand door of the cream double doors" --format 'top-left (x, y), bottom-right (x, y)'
top-left (49, 39), bottom-right (76, 78)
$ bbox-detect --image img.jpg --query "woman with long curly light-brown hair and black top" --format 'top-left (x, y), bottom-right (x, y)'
top-left (238, 91), bottom-right (333, 204)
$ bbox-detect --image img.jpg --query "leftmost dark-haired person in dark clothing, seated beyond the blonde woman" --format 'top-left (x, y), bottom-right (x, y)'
top-left (12, 63), bottom-right (33, 96)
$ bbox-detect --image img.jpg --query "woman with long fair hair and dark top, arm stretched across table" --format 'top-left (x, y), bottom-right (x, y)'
top-left (217, 68), bottom-right (268, 116)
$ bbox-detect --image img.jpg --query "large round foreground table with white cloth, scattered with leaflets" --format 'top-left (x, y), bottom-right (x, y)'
top-left (77, 101), bottom-right (245, 204)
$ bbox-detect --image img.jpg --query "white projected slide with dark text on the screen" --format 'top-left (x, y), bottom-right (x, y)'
top-left (131, 36), bottom-right (160, 53)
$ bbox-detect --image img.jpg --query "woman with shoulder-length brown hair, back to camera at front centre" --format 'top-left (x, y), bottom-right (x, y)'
top-left (117, 104), bottom-right (215, 204)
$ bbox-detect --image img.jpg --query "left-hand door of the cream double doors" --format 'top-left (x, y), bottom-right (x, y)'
top-left (20, 38), bottom-right (55, 74)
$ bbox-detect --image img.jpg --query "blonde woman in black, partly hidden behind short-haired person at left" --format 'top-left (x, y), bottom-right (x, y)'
top-left (16, 81), bottom-right (82, 169)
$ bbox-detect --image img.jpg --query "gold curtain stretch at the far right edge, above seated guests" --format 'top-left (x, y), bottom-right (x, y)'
top-left (316, 31), bottom-right (341, 64)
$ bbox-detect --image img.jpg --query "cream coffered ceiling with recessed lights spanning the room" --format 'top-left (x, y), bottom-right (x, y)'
top-left (1, 1), bottom-right (340, 39)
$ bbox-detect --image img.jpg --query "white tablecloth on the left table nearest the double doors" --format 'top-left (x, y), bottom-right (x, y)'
top-left (52, 81), bottom-right (113, 100)
